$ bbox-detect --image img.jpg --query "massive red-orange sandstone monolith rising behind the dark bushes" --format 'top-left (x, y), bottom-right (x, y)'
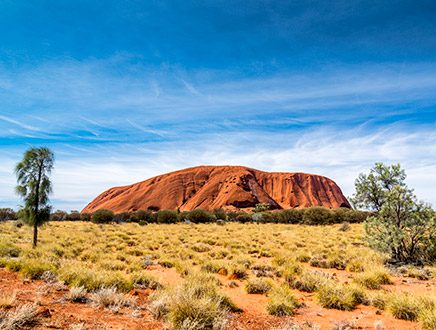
top-left (82, 166), bottom-right (350, 213)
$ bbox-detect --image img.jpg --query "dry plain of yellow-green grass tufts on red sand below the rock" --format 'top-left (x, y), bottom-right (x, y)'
top-left (0, 221), bottom-right (436, 329)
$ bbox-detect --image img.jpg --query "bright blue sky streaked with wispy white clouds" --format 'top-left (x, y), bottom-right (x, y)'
top-left (0, 0), bottom-right (436, 210)
